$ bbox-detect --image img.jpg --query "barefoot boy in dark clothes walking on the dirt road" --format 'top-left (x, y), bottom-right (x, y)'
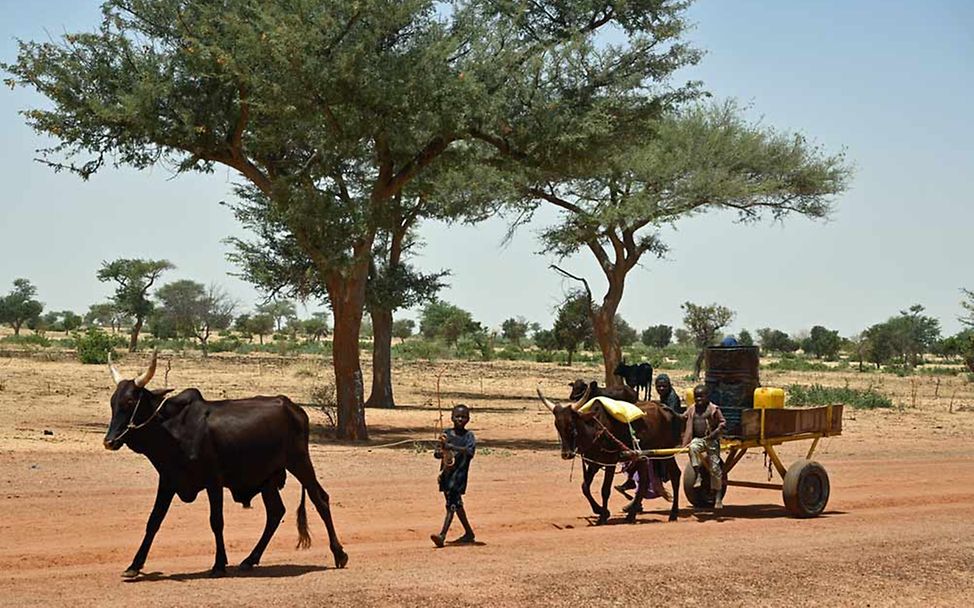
top-left (430, 405), bottom-right (477, 547)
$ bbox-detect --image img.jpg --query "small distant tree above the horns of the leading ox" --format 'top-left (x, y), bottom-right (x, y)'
top-left (98, 258), bottom-right (175, 353)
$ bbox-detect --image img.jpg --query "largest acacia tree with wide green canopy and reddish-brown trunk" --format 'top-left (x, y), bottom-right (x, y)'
top-left (3, 0), bottom-right (716, 439)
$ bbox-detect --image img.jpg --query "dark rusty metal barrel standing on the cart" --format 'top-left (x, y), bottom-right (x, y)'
top-left (704, 346), bottom-right (761, 411)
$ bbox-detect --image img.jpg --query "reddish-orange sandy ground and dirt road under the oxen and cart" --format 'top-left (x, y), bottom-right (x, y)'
top-left (0, 358), bottom-right (974, 607)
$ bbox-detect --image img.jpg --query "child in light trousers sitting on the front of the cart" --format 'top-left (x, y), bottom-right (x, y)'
top-left (683, 384), bottom-right (727, 509)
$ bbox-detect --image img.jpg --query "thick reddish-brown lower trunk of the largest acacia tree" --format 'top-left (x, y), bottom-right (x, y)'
top-left (328, 278), bottom-right (369, 440)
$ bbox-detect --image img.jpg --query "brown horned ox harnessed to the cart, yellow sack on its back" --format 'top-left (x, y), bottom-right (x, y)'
top-left (538, 388), bottom-right (683, 524)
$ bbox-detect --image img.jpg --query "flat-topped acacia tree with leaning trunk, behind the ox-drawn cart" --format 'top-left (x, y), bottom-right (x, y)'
top-left (525, 102), bottom-right (850, 386)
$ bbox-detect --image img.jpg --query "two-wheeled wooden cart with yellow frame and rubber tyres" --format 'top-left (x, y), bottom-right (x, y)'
top-left (644, 405), bottom-right (843, 517)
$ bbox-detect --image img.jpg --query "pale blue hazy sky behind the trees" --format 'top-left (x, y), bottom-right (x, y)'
top-left (0, 0), bottom-right (974, 335)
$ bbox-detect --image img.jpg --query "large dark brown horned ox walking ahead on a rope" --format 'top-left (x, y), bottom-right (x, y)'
top-left (104, 353), bottom-right (348, 578)
